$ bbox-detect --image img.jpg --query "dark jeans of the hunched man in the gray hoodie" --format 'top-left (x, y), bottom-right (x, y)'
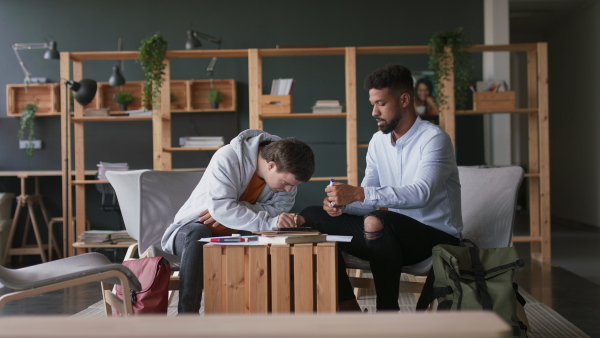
top-left (173, 222), bottom-right (249, 314)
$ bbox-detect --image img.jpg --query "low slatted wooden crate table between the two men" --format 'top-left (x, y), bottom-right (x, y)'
top-left (204, 242), bottom-right (337, 314)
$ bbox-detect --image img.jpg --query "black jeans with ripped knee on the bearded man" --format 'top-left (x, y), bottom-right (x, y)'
top-left (300, 206), bottom-right (459, 311)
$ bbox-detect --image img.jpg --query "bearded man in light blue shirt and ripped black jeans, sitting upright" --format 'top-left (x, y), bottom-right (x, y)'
top-left (299, 65), bottom-right (462, 311)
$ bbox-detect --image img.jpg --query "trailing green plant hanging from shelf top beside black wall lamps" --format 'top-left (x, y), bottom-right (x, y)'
top-left (138, 33), bottom-right (167, 108)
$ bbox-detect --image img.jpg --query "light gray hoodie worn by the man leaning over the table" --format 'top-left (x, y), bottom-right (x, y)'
top-left (161, 129), bottom-right (296, 253)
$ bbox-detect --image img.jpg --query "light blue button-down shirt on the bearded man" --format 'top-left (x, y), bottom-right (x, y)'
top-left (344, 117), bottom-right (462, 237)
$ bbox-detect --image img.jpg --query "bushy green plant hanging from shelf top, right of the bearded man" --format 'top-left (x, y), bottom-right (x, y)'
top-left (429, 27), bottom-right (473, 109)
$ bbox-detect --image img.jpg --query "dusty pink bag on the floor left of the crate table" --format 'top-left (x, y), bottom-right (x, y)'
top-left (113, 257), bottom-right (171, 316)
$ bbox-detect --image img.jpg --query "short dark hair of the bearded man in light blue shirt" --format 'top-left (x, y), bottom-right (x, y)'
top-left (364, 64), bottom-right (414, 98)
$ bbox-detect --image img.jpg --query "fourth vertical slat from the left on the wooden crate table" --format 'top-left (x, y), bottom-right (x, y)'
top-left (271, 244), bottom-right (291, 313)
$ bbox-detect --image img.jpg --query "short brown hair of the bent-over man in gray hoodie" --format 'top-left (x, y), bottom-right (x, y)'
top-left (261, 137), bottom-right (315, 182)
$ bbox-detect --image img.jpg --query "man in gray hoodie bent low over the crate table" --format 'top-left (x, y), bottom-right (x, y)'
top-left (161, 129), bottom-right (315, 313)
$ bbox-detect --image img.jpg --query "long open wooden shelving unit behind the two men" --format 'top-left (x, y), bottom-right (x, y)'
top-left (59, 43), bottom-right (551, 261)
